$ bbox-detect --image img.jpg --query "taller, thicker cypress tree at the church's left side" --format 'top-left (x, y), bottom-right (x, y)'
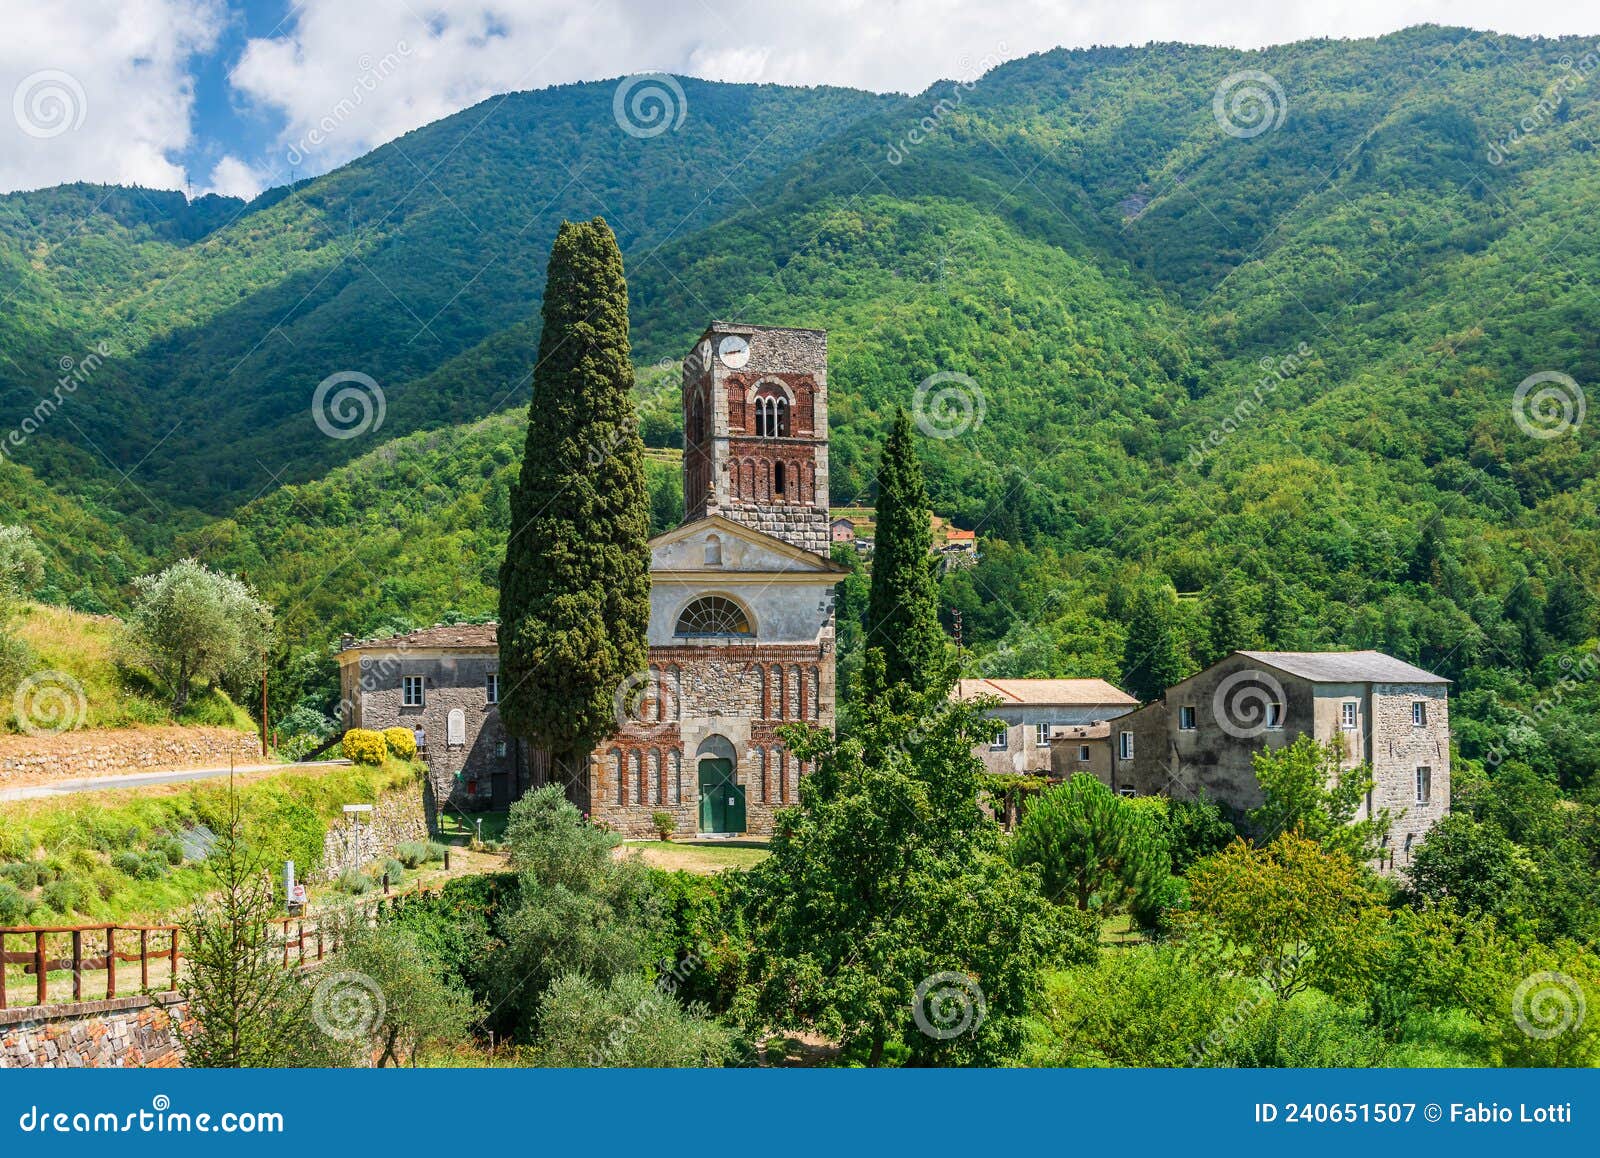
top-left (499, 218), bottom-right (650, 776)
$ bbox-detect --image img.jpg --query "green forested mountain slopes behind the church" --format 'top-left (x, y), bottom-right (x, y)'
top-left (9, 27), bottom-right (1600, 777)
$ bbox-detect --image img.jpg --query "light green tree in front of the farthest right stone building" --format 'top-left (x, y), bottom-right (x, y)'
top-left (1250, 736), bottom-right (1390, 861)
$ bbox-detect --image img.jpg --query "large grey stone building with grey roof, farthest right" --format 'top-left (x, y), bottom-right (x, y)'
top-left (1112, 651), bottom-right (1450, 867)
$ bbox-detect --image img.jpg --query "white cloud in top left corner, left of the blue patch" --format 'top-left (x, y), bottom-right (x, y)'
top-left (0, 0), bottom-right (221, 189)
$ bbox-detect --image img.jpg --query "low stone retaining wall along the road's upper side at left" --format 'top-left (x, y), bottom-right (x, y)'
top-left (0, 726), bottom-right (262, 785)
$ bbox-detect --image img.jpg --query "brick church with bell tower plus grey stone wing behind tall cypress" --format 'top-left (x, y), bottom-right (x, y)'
top-left (339, 321), bottom-right (846, 837)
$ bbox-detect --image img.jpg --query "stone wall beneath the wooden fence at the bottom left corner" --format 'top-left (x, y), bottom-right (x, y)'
top-left (0, 993), bottom-right (184, 1070)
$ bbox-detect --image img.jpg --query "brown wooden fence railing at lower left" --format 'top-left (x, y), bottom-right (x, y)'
top-left (0, 916), bottom-right (337, 1009)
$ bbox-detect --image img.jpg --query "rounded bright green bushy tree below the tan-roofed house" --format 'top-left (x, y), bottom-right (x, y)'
top-left (1010, 773), bottom-right (1171, 913)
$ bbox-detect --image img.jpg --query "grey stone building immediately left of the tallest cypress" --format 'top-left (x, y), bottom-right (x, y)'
top-left (338, 624), bottom-right (530, 809)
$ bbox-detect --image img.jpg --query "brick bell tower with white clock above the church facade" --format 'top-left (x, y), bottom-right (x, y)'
top-left (683, 321), bottom-right (829, 558)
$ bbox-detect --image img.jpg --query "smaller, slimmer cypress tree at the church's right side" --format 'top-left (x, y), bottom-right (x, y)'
top-left (866, 409), bottom-right (954, 693)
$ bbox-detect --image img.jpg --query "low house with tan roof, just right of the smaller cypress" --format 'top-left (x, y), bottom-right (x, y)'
top-left (952, 680), bottom-right (1139, 776)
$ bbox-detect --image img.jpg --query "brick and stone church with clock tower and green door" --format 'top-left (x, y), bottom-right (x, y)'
top-left (568, 321), bottom-right (845, 837)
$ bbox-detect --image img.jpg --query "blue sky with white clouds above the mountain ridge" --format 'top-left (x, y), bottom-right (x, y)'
top-left (0, 0), bottom-right (1600, 197)
